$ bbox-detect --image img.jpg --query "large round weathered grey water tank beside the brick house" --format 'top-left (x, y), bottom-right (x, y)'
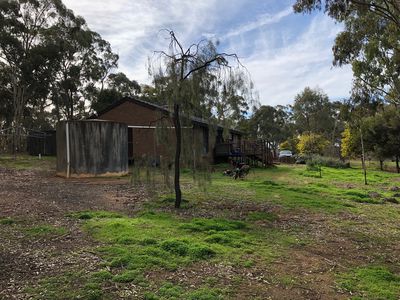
top-left (57, 120), bottom-right (128, 177)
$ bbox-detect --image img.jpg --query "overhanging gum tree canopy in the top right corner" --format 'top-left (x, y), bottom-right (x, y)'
top-left (294, 0), bottom-right (400, 104)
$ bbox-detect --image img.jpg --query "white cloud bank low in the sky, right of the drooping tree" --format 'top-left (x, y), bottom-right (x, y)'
top-left (243, 16), bottom-right (352, 105)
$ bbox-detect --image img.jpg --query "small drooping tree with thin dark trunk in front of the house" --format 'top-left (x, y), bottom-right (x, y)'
top-left (152, 31), bottom-right (251, 208)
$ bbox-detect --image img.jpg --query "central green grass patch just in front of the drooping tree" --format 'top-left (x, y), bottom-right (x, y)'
top-left (84, 213), bottom-right (296, 280)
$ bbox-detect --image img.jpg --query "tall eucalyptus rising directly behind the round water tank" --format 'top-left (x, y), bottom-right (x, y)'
top-left (52, 11), bottom-right (118, 119)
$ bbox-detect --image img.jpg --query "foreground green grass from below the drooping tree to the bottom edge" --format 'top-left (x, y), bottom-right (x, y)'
top-left (27, 211), bottom-right (298, 300)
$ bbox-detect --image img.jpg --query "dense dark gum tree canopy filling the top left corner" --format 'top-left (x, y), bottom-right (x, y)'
top-left (0, 0), bottom-right (118, 136)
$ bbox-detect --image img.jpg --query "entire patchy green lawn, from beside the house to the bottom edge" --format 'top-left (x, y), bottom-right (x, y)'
top-left (21, 166), bottom-right (400, 300)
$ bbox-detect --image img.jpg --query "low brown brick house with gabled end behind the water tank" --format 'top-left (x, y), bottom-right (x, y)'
top-left (92, 97), bottom-right (242, 162)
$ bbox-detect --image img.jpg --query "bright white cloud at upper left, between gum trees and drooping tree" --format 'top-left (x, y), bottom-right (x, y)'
top-left (64, 0), bottom-right (217, 82)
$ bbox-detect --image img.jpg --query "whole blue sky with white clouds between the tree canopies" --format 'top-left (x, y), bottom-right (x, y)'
top-left (63, 0), bottom-right (352, 105)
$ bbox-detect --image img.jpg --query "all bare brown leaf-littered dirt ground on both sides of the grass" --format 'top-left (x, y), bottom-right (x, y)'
top-left (0, 168), bottom-right (400, 299)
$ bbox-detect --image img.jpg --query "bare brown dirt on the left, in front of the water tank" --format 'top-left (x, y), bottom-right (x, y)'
top-left (0, 168), bottom-right (145, 299)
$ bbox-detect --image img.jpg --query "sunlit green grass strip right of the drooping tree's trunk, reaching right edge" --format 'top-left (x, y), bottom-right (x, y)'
top-left (170, 166), bottom-right (398, 213)
